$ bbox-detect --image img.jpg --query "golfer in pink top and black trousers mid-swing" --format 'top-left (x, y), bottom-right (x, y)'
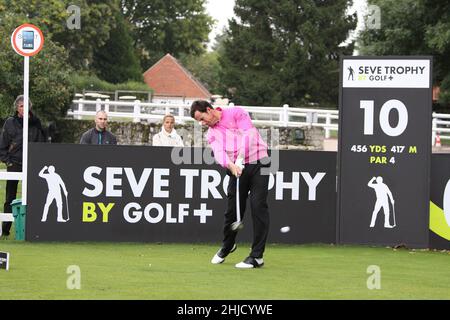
top-left (191, 100), bottom-right (270, 268)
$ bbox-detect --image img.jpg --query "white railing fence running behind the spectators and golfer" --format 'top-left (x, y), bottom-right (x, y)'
top-left (67, 99), bottom-right (450, 145)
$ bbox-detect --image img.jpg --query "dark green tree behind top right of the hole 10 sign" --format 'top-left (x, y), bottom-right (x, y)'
top-left (358, 0), bottom-right (450, 104)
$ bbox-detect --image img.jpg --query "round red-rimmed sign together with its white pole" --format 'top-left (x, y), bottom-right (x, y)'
top-left (11, 24), bottom-right (44, 205)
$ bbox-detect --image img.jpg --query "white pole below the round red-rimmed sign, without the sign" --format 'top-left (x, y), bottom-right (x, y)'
top-left (22, 56), bottom-right (30, 205)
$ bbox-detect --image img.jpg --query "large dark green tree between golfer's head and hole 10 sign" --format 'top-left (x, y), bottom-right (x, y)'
top-left (219, 0), bottom-right (356, 107)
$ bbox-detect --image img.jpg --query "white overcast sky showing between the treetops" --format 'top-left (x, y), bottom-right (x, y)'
top-left (206, 0), bottom-right (366, 50)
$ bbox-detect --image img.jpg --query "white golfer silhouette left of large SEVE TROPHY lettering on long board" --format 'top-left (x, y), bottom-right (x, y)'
top-left (39, 166), bottom-right (69, 222)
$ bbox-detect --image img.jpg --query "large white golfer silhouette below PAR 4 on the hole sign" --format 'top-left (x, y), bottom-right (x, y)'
top-left (367, 177), bottom-right (396, 228)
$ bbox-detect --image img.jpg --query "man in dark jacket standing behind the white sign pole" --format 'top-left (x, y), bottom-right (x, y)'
top-left (0, 95), bottom-right (45, 236)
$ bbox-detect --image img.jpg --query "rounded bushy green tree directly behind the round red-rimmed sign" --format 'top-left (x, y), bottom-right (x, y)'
top-left (0, 21), bottom-right (74, 121)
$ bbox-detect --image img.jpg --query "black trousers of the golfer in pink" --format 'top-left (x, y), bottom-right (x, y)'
top-left (223, 161), bottom-right (270, 258)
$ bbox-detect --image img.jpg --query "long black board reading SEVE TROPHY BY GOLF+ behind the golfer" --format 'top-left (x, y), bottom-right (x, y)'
top-left (26, 143), bottom-right (336, 243)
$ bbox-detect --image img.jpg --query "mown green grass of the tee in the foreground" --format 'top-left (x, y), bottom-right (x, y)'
top-left (0, 240), bottom-right (450, 300)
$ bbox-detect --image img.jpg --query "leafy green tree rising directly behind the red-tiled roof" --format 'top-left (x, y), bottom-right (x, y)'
top-left (121, 0), bottom-right (213, 70)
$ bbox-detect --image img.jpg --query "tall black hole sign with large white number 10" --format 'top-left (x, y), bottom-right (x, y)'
top-left (337, 57), bottom-right (432, 247)
